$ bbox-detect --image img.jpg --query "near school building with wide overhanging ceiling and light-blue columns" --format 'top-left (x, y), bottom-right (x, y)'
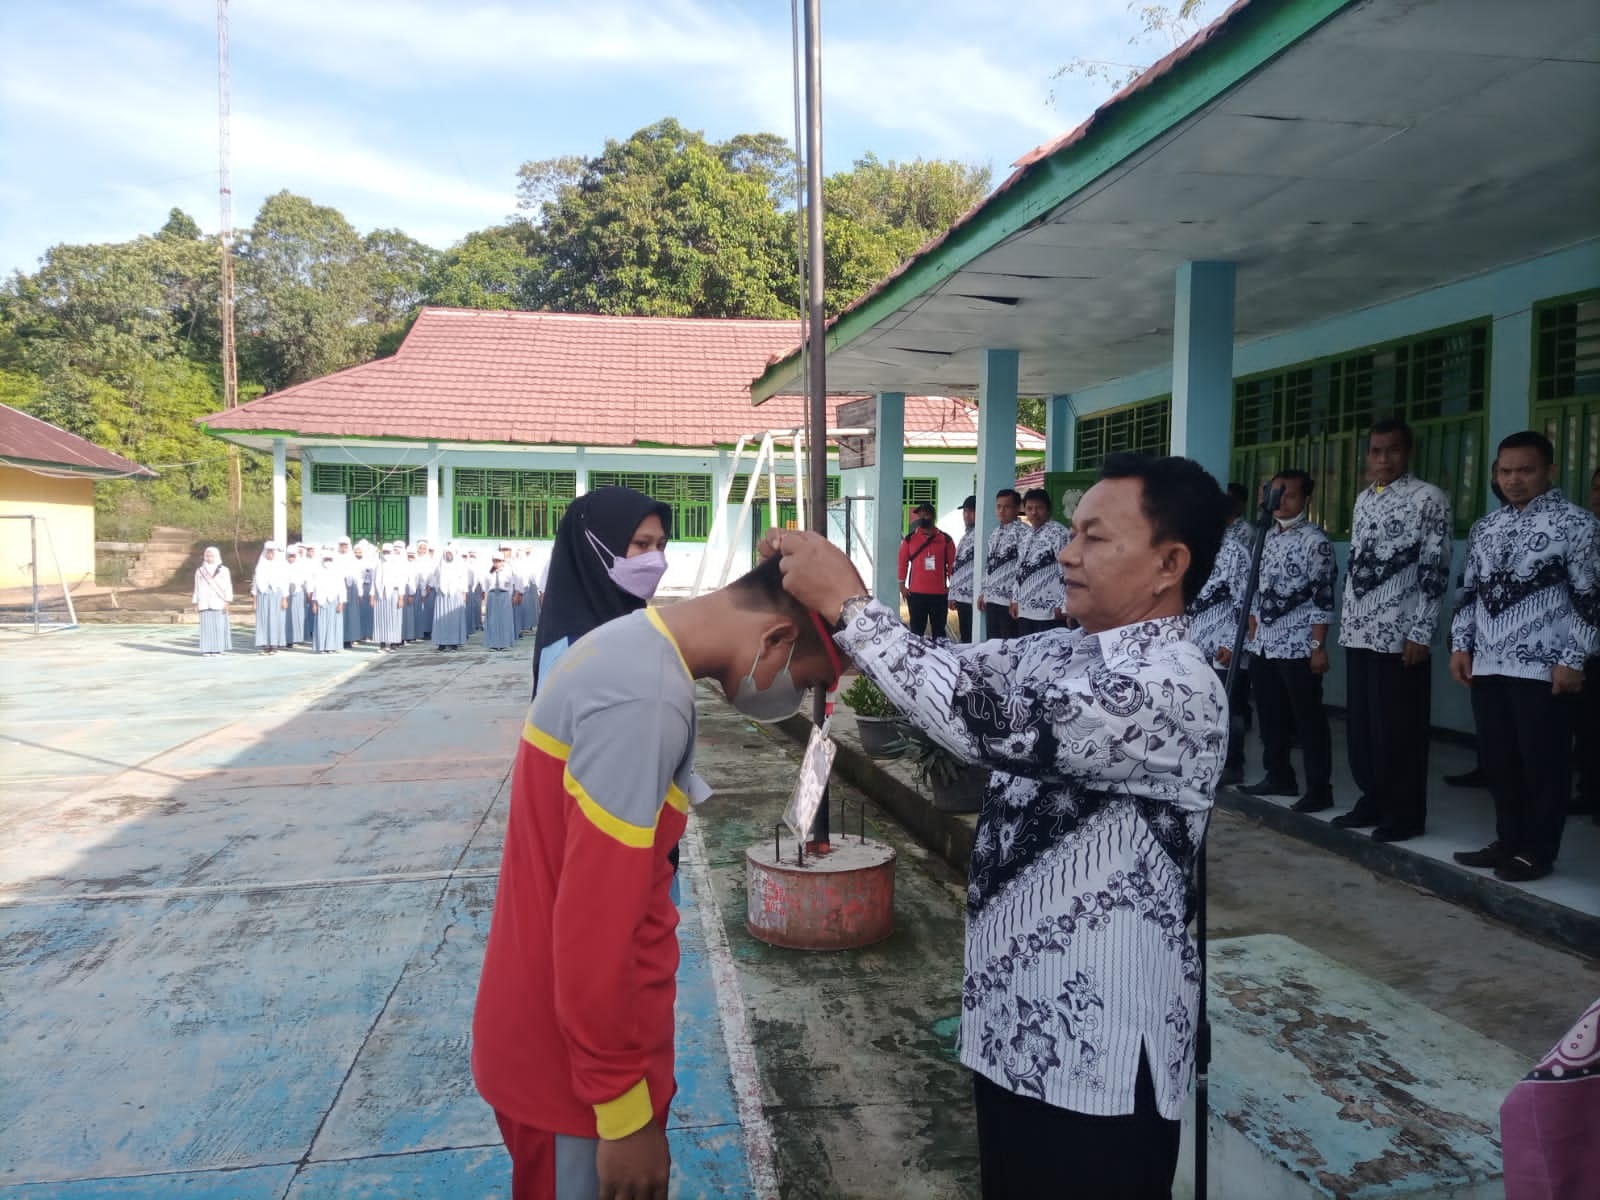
top-left (752, 0), bottom-right (1600, 730)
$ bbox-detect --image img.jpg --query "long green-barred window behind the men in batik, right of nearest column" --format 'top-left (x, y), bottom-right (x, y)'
top-left (1232, 320), bottom-right (1490, 539)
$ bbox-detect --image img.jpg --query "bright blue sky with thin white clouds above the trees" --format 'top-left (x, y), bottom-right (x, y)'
top-left (0, 0), bottom-right (1224, 277)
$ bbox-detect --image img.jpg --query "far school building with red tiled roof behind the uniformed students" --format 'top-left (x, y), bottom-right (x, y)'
top-left (205, 309), bottom-right (1045, 592)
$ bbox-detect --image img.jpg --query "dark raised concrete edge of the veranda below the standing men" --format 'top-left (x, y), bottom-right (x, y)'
top-left (778, 717), bottom-right (1600, 958)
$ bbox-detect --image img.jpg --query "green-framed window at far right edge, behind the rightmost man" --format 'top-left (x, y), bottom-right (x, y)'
top-left (1530, 291), bottom-right (1600, 504)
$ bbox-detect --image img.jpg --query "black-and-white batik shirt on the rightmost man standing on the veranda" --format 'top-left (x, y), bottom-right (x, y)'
top-left (1450, 488), bottom-right (1600, 686)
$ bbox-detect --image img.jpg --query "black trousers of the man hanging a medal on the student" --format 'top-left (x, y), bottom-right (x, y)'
top-left (973, 1054), bottom-right (1178, 1200)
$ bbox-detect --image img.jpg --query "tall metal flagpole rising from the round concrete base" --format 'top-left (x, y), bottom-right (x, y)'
top-left (805, 0), bottom-right (829, 845)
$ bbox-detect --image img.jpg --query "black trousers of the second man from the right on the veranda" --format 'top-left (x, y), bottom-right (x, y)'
top-left (1344, 650), bottom-right (1434, 832)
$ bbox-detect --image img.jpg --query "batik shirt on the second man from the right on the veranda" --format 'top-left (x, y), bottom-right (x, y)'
top-left (1339, 475), bottom-right (1451, 654)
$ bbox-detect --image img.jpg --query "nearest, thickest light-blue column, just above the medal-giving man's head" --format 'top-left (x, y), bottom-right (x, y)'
top-left (1171, 262), bottom-right (1234, 485)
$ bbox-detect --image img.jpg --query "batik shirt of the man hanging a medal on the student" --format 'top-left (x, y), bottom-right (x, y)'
top-left (835, 602), bottom-right (1227, 1120)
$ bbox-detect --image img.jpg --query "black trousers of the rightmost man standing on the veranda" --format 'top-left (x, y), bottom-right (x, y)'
top-left (1472, 675), bottom-right (1573, 866)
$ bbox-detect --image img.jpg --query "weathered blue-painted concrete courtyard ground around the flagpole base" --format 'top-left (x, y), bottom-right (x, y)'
top-left (0, 626), bottom-right (1600, 1200)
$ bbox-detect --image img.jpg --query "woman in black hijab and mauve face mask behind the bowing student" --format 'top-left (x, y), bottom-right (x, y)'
top-left (533, 488), bottom-right (672, 694)
